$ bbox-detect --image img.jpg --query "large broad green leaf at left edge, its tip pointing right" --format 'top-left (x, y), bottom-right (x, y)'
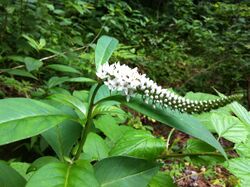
top-left (0, 98), bottom-right (71, 145)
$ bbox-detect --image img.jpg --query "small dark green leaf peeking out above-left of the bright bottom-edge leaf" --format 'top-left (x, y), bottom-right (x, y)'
top-left (27, 156), bottom-right (59, 173)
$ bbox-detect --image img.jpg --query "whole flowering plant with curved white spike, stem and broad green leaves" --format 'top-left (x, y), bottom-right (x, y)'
top-left (0, 36), bottom-right (242, 187)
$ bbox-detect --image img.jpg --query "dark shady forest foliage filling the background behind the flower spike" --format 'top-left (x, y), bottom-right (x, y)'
top-left (0, 0), bottom-right (250, 98)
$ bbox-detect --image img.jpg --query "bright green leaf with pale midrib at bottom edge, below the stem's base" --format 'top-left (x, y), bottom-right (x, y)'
top-left (26, 160), bottom-right (99, 187)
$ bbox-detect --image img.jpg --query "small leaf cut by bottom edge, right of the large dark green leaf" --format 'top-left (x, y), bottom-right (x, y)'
top-left (149, 171), bottom-right (177, 187)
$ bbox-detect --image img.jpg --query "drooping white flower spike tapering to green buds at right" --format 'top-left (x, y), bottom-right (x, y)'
top-left (96, 62), bottom-right (238, 113)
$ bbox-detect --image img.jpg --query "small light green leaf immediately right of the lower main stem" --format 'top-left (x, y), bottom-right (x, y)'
top-left (82, 132), bottom-right (109, 161)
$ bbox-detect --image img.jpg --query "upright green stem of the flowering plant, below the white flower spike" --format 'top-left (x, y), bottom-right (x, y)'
top-left (73, 84), bottom-right (101, 160)
